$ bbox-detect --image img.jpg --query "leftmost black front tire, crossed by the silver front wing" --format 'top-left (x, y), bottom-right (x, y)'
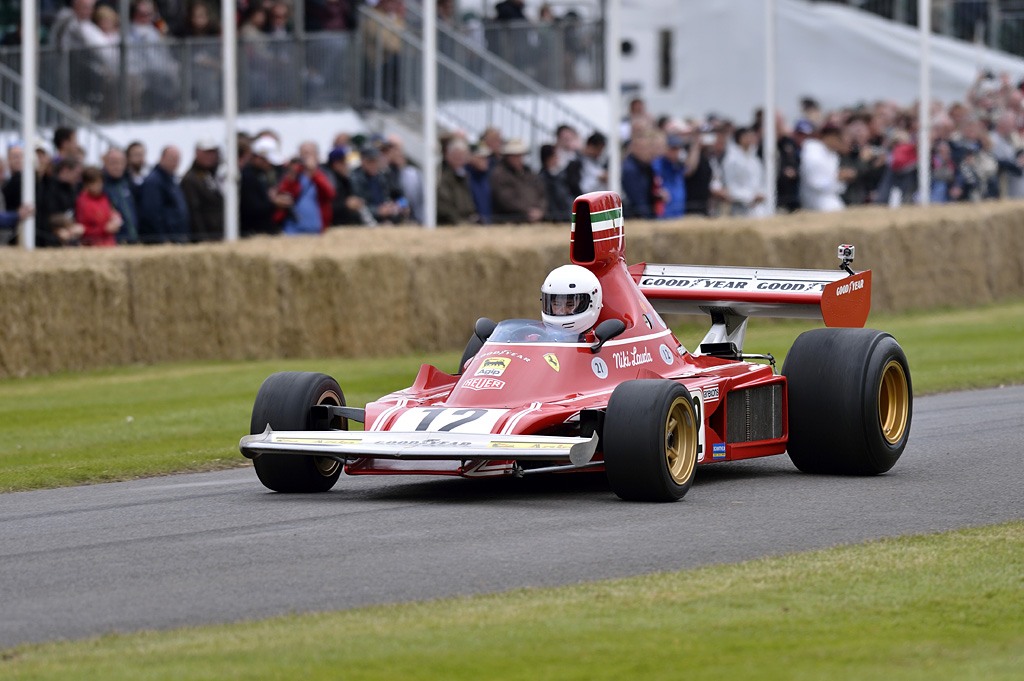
top-left (249, 372), bottom-right (348, 493)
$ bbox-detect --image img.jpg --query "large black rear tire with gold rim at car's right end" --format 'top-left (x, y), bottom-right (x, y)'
top-left (782, 329), bottom-right (913, 475)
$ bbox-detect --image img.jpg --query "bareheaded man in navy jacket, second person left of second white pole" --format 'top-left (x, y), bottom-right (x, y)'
top-left (138, 145), bottom-right (190, 244)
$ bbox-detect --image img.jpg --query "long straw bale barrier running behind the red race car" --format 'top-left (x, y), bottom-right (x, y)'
top-left (0, 202), bottom-right (1024, 378)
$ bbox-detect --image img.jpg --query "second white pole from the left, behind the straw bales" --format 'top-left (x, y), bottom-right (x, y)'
top-left (220, 0), bottom-right (239, 242)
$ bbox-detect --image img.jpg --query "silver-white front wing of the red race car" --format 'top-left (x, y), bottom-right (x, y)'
top-left (239, 426), bottom-right (597, 466)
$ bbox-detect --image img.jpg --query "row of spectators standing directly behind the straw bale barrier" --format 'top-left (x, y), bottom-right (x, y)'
top-left (9, 62), bottom-right (1024, 246)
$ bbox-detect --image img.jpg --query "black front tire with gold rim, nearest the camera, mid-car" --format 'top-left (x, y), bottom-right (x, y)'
top-left (603, 379), bottom-right (700, 502)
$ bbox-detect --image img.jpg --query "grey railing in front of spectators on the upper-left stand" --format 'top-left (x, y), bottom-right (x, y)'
top-left (0, 32), bottom-right (361, 123)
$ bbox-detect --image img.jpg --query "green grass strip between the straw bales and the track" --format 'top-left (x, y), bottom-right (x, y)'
top-left (0, 294), bottom-right (1024, 492)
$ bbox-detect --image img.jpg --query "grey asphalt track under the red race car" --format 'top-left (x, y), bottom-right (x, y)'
top-left (0, 386), bottom-right (1024, 648)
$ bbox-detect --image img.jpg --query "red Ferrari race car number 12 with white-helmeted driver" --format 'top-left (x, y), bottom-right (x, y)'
top-left (240, 191), bottom-right (912, 501)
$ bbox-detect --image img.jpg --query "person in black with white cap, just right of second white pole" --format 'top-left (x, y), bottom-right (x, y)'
top-left (239, 136), bottom-right (295, 237)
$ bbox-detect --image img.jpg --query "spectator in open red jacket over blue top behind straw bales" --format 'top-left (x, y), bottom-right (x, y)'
top-left (278, 141), bottom-right (335, 235)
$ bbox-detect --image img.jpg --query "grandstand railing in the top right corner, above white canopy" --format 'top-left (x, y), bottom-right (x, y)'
top-left (813, 0), bottom-right (1024, 56)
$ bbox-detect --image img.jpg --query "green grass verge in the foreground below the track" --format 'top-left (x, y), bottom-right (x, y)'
top-left (0, 521), bottom-right (1024, 681)
